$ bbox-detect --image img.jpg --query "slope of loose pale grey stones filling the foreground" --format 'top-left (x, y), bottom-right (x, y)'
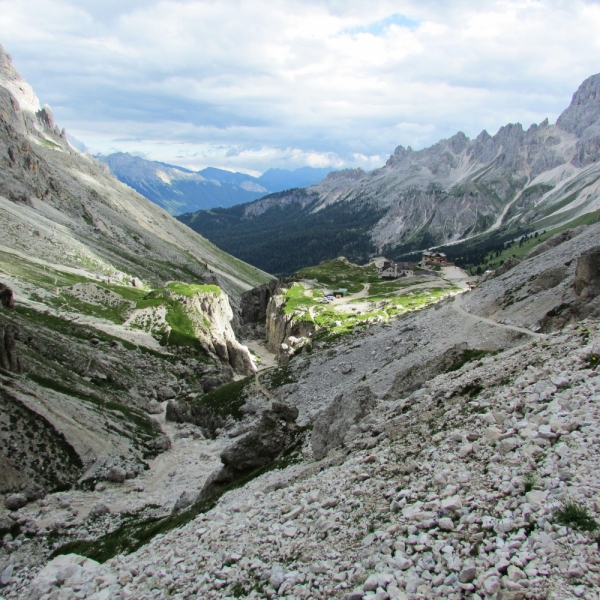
top-left (2, 322), bottom-right (600, 600)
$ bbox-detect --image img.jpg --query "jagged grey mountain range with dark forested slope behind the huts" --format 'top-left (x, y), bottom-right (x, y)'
top-left (179, 75), bottom-right (600, 275)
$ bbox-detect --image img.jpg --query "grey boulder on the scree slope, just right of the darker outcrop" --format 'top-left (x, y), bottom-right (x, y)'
top-left (311, 386), bottom-right (377, 460)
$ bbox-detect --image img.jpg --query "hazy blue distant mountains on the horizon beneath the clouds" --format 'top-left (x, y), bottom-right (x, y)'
top-left (96, 152), bottom-right (331, 215)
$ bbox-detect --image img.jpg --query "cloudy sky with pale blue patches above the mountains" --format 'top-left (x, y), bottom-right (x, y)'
top-left (0, 0), bottom-right (600, 174)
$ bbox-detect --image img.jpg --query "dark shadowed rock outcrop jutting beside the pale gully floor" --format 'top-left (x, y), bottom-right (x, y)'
top-left (200, 402), bottom-right (298, 498)
